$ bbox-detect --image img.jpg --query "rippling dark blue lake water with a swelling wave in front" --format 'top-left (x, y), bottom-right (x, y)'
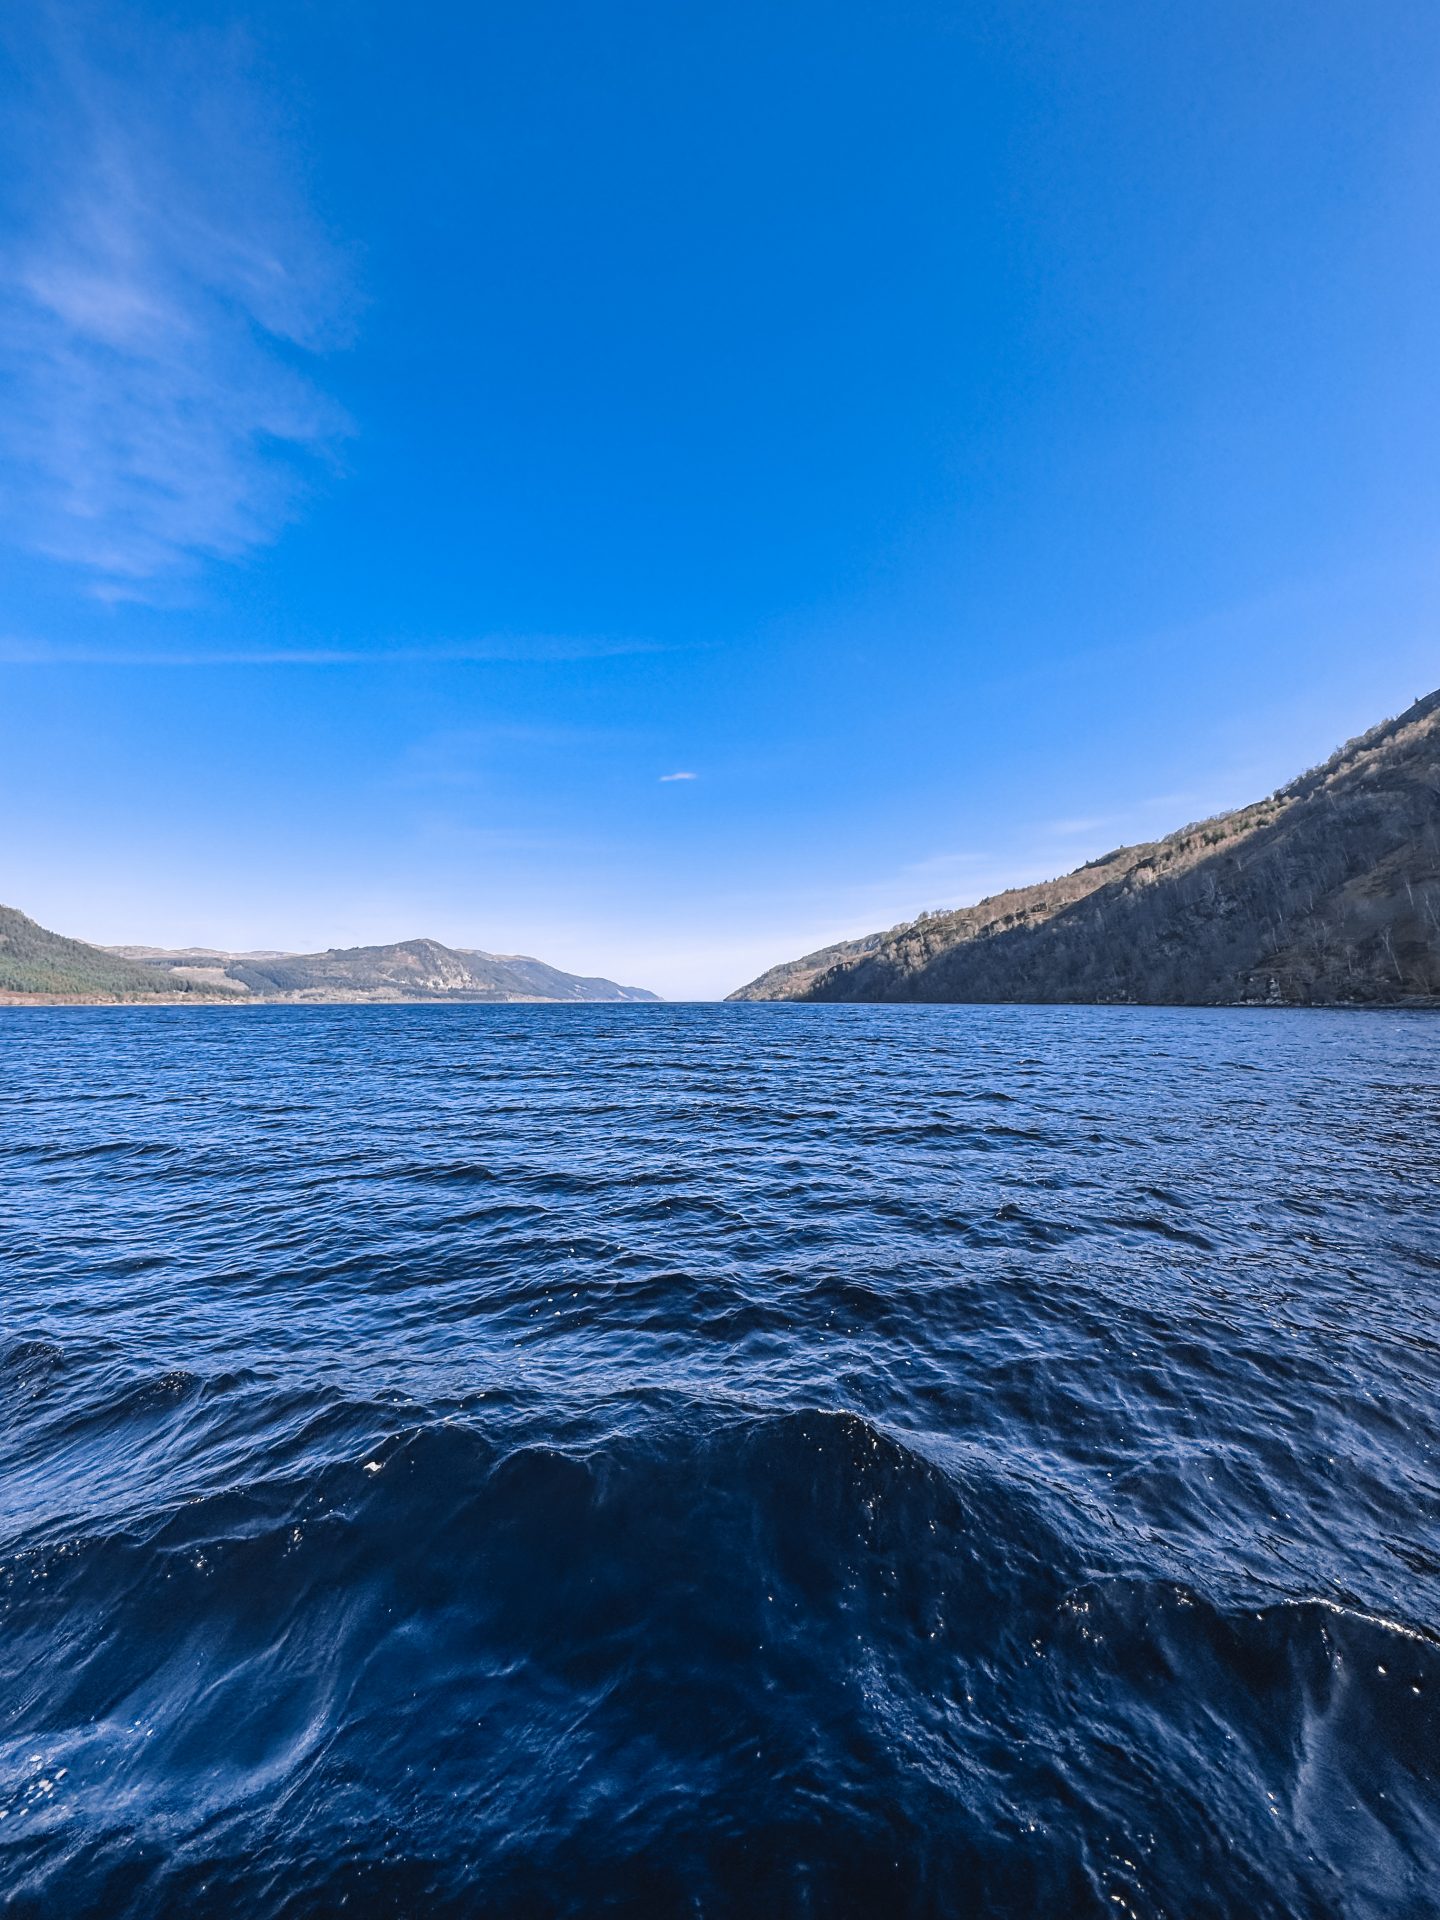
top-left (0, 1006), bottom-right (1440, 1920)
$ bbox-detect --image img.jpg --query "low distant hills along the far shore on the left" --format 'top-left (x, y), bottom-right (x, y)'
top-left (0, 906), bottom-right (659, 1002)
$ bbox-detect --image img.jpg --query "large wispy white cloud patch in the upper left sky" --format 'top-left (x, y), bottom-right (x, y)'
top-left (0, 6), bottom-right (353, 597)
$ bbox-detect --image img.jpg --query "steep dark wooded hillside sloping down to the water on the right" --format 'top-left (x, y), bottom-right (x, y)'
top-left (730, 693), bottom-right (1440, 1006)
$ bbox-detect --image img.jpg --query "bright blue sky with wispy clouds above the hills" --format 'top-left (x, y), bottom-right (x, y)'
top-left (0, 0), bottom-right (1440, 995)
